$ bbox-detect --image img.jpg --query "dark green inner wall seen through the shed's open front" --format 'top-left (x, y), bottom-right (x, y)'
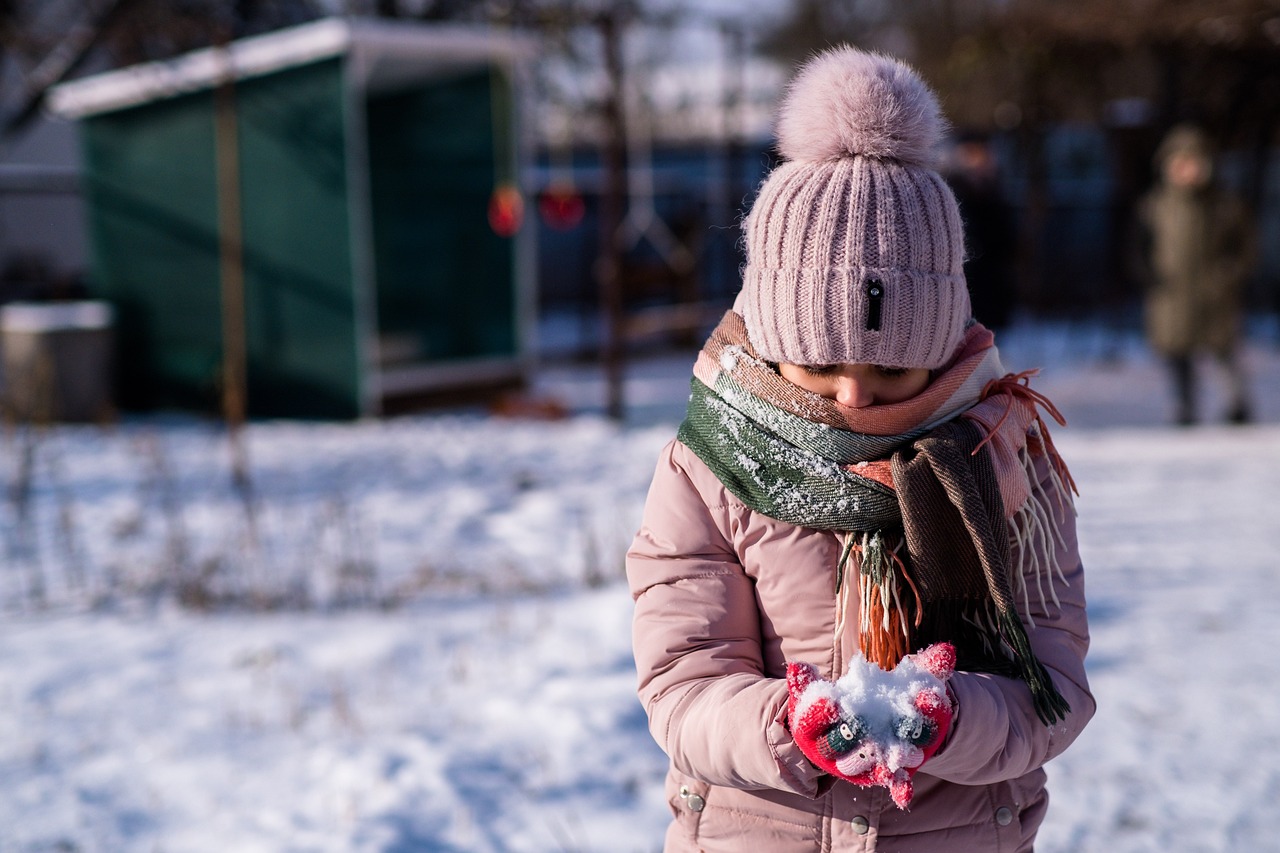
top-left (367, 70), bottom-right (517, 362)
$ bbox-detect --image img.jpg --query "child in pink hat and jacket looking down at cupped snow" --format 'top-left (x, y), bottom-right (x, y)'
top-left (627, 47), bottom-right (1094, 853)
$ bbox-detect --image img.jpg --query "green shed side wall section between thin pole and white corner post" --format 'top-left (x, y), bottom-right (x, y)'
top-left (237, 59), bottom-right (361, 418)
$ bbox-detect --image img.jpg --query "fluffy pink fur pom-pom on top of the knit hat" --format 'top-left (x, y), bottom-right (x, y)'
top-left (777, 46), bottom-right (946, 167)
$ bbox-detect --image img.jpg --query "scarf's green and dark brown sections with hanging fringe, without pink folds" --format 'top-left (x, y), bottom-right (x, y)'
top-left (677, 373), bottom-right (1069, 725)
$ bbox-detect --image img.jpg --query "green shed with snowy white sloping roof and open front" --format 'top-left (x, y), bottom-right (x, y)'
top-left (50, 18), bottom-right (535, 418)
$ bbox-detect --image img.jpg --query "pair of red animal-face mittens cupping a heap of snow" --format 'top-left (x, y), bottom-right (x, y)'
top-left (787, 643), bottom-right (956, 808)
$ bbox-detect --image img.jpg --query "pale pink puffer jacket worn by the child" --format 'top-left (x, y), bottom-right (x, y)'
top-left (627, 441), bottom-right (1094, 853)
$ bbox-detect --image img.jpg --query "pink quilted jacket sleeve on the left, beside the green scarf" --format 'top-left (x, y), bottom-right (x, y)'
top-left (627, 442), bottom-right (820, 797)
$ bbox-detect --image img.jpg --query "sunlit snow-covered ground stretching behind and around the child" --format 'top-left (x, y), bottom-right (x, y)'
top-left (0, 315), bottom-right (1280, 853)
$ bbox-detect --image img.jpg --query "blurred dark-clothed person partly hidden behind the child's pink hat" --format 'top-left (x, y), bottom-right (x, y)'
top-left (946, 131), bottom-right (1018, 332)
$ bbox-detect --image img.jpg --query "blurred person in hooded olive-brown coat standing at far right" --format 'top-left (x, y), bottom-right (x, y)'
top-left (1138, 124), bottom-right (1256, 425)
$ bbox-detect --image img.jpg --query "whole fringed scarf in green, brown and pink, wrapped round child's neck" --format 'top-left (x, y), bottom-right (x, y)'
top-left (678, 311), bottom-right (1074, 725)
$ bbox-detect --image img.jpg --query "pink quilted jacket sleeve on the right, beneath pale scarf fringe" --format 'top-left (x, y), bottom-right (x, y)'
top-left (920, 445), bottom-right (1096, 785)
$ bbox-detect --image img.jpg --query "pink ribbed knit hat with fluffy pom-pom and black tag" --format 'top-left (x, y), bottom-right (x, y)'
top-left (735, 47), bottom-right (970, 369)
